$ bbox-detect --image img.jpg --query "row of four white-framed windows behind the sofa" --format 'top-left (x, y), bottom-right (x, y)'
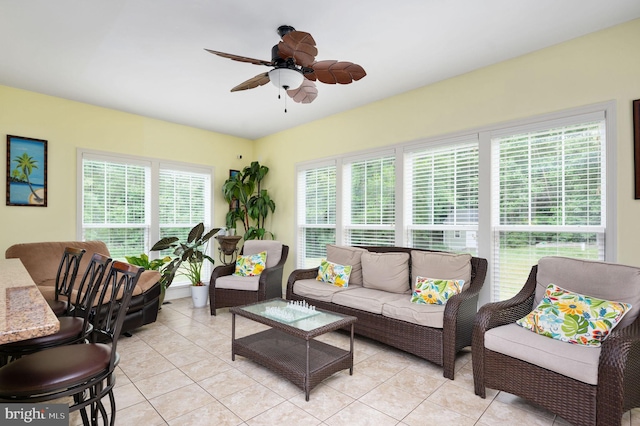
top-left (296, 102), bottom-right (616, 303)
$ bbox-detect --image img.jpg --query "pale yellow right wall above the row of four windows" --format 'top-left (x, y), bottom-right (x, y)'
top-left (258, 20), bottom-right (640, 276)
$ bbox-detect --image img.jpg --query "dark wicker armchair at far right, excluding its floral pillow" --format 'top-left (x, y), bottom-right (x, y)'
top-left (472, 257), bottom-right (640, 426)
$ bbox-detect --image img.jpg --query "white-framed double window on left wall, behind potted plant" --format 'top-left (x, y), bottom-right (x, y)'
top-left (78, 151), bottom-right (212, 284)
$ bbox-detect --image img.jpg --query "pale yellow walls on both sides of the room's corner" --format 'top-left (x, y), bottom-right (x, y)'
top-left (0, 20), bottom-right (640, 286)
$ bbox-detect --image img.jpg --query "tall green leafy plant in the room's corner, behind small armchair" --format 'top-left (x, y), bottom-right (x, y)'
top-left (222, 161), bottom-right (276, 241)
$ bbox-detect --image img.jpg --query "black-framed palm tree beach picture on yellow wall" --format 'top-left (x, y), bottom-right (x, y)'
top-left (6, 135), bottom-right (48, 207)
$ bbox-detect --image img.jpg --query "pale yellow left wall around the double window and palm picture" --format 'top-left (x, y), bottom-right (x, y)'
top-left (0, 86), bottom-right (254, 253)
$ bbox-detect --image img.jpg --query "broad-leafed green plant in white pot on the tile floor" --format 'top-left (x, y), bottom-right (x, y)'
top-left (151, 222), bottom-right (220, 308)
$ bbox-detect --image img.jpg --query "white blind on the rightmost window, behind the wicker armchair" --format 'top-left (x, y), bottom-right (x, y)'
top-left (492, 119), bottom-right (606, 300)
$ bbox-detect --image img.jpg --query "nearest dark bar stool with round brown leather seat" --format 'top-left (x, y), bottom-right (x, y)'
top-left (0, 262), bottom-right (144, 425)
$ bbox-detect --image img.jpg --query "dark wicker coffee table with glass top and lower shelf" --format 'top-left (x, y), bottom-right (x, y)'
top-left (229, 299), bottom-right (357, 401)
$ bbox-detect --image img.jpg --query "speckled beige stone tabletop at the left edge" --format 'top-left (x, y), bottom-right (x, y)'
top-left (0, 259), bottom-right (60, 345)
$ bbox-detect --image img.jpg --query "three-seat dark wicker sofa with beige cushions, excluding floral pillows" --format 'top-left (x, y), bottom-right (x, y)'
top-left (286, 245), bottom-right (487, 380)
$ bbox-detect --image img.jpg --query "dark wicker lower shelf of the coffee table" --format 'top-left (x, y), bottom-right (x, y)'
top-left (231, 329), bottom-right (353, 401)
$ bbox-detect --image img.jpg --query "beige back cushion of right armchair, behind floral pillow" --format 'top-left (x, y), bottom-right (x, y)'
top-left (534, 256), bottom-right (640, 328)
